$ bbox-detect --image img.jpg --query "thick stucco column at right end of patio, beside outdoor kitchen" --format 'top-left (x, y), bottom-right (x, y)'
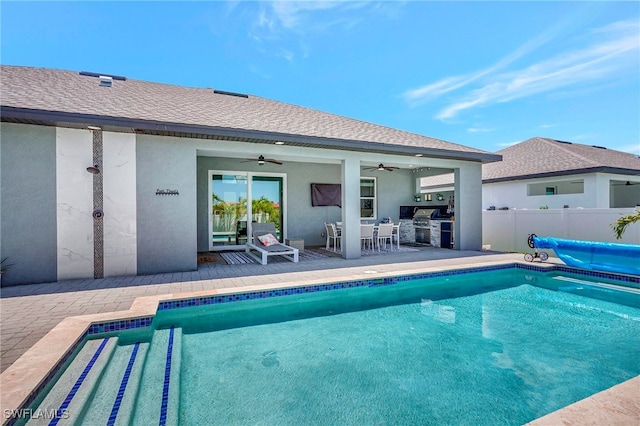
top-left (453, 162), bottom-right (482, 250)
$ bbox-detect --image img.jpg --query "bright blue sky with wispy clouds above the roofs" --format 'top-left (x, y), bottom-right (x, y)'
top-left (0, 1), bottom-right (640, 154)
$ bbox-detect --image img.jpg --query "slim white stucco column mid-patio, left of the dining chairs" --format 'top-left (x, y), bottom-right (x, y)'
top-left (342, 157), bottom-right (360, 259)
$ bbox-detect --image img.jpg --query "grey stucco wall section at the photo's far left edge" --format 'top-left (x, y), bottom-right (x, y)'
top-left (0, 123), bottom-right (57, 286)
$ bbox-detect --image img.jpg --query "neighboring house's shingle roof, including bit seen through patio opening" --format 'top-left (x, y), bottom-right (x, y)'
top-left (421, 137), bottom-right (640, 188)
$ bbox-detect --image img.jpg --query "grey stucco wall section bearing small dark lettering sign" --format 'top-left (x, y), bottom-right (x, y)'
top-left (136, 135), bottom-right (197, 275)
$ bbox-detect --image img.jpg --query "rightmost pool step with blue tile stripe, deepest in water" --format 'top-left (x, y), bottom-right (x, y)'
top-left (130, 327), bottom-right (182, 426)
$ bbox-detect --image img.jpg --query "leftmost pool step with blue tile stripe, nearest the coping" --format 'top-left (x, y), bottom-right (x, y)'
top-left (27, 337), bottom-right (117, 426)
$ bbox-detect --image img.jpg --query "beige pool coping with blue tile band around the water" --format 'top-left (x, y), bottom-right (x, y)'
top-left (0, 260), bottom-right (640, 426)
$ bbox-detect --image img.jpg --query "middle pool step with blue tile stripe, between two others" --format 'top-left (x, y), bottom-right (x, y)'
top-left (77, 343), bottom-right (149, 426)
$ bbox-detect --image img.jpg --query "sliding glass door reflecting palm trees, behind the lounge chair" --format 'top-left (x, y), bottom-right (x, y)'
top-left (209, 171), bottom-right (285, 250)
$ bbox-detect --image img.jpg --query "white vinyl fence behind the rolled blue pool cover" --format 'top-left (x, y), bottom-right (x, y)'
top-left (482, 208), bottom-right (640, 255)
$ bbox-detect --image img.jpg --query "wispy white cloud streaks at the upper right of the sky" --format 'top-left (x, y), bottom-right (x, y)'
top-left (403, 20), bottom-right (640, 120)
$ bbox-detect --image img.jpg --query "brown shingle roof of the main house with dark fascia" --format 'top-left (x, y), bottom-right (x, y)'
top-left (0, 65), bottom-right (500, 162)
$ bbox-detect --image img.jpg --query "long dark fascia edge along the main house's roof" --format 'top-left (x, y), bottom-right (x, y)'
top-left (0, 105), bottom-right (502, 163)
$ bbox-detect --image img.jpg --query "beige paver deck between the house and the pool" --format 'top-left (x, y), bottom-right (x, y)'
top-left (0, 247), bottom-right (640, 426)
